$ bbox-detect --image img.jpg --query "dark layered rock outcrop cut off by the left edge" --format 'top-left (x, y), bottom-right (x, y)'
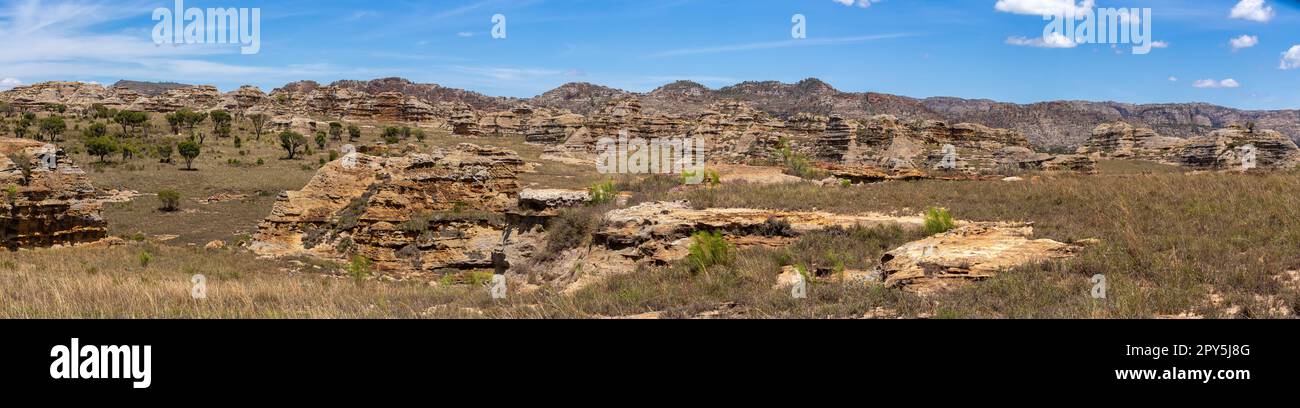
top-left (0, 138), bottom-right (108, 249)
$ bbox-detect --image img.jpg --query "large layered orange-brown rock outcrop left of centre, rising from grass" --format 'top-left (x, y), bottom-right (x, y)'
top-left (252, 144), bottom-right (532, 278)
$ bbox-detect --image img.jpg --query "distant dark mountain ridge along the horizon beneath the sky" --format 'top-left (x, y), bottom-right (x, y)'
top-left (15, 78), bottom-right (1300, 149)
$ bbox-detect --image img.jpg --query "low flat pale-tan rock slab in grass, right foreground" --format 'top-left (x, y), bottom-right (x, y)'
top-left (880, 223), bottom-right (1079, 294)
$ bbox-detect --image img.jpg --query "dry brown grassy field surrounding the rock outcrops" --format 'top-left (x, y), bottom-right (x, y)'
top-left (0, 110), bottom-right (1300, 318)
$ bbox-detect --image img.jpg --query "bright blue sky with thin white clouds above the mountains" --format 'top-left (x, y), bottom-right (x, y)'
top-left (0, 0), bottom-right (1300, 109)
